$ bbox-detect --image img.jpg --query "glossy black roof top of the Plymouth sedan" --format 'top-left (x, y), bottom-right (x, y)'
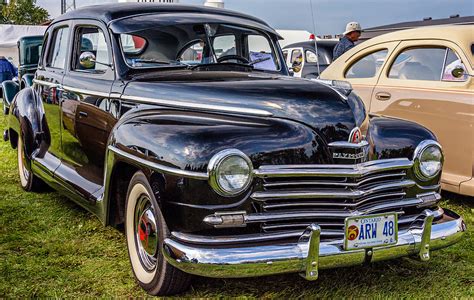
top-left (52, 3), bottom-right (268, 26)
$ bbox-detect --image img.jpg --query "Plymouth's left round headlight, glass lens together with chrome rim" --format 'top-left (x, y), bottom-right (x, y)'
top-left (208, 149), bottom-right (253, 197)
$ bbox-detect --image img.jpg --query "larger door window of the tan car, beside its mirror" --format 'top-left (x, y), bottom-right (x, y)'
top-left (388, 47), bottom-right (446, 81)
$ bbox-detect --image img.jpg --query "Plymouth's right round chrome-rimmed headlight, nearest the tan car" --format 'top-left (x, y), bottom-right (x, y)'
top-left (413, 140), bottom-right (444, 181)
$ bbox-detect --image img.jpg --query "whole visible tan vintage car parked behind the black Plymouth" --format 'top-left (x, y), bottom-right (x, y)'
top-left (321, 25), bottom-right (474, 196)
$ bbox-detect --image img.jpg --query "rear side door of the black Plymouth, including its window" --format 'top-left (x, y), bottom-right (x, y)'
top-left (34, 22), bottom-right (70, 178)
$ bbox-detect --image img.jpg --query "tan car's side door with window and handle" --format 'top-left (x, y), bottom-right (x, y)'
top-left (370, 40), bottom-right (474, 192)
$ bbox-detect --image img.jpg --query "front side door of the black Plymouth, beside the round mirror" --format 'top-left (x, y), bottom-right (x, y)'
top-left (57, 21), bottom-right (116, 200)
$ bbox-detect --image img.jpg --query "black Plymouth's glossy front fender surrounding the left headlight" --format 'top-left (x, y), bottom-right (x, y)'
top-left (106, 110), bottom-right (332, 232)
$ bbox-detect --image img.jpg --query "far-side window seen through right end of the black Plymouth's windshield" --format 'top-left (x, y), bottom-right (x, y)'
top-left (247, 35), bottom-right (280, 71)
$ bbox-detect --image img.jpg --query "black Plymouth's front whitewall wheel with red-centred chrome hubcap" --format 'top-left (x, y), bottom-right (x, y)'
top-left (125, 172), bottom-right (191, 296)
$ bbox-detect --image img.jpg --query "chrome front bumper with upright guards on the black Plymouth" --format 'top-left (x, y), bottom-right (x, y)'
top-left (163, 209), bottom-right (466, 280)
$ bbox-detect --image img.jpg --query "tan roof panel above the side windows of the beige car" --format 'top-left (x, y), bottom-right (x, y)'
top-left (355, 25), bottom-right (474, 68)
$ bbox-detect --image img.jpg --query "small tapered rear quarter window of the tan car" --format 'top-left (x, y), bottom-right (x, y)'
top-left (344, 49), bottom-right (388, 78)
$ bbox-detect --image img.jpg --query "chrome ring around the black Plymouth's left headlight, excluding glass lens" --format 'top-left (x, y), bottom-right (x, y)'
top-left (207, 149), bottom-right (253, 197)
